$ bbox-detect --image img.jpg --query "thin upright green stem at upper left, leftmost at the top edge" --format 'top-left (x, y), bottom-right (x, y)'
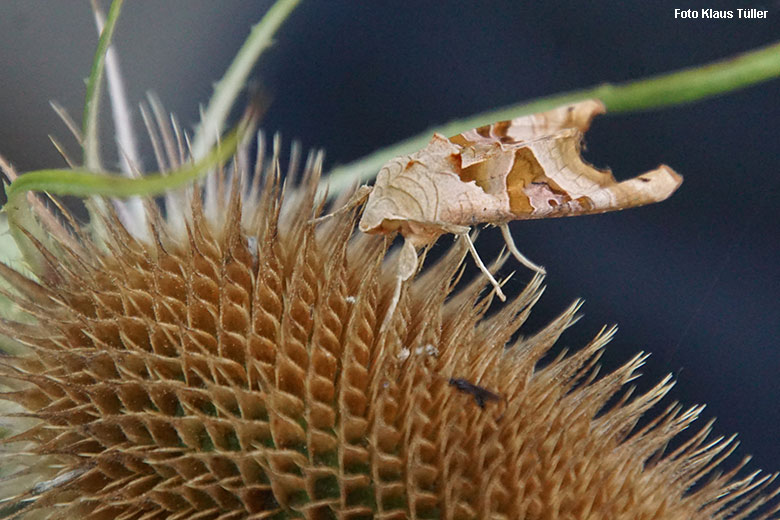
top-left (82, 0), bottom-right (124, 170)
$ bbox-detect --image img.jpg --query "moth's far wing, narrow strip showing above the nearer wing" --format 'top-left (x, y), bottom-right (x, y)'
top-left (450, 99), bottom-right (606, 148)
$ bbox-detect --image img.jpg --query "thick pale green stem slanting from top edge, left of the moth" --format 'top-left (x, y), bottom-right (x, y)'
top-left (192, 0), bottom-right (300, 159)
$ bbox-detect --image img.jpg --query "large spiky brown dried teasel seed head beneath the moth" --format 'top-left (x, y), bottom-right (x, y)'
top-left (0, 127), bottom-right (772, 520)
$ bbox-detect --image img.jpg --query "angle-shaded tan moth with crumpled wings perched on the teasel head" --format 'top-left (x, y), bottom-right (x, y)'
top-left (320, 100), bottom-right (682, 327)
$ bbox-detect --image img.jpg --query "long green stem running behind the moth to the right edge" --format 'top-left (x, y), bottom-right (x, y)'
top-left (324, 43), bottom-right (780, 197)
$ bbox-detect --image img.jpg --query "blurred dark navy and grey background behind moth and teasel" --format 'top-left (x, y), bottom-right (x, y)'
top-left (0, 0), bottom-right (780, 478)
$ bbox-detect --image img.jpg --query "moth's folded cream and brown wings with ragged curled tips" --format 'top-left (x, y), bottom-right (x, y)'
top-left (450, 100), bottom-right (682, 221)
